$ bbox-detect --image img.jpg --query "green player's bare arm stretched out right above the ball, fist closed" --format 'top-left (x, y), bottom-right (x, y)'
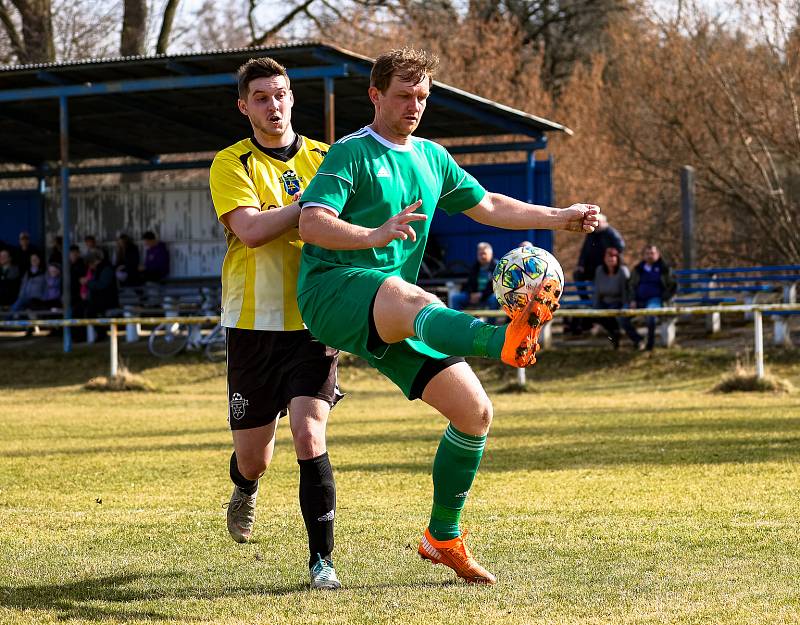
top-left (464, 193), bottom-right (600, 232)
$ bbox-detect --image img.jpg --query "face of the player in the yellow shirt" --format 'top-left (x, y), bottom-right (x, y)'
top-left (239, 76), bottom-right (294, 147)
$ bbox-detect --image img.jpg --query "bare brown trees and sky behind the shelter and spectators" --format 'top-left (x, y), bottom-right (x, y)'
top-left (0, 0), bottom-right (800, 269)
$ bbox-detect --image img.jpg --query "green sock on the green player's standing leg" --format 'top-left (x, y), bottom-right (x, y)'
top-left (428, 424), bottom-right (486, 540)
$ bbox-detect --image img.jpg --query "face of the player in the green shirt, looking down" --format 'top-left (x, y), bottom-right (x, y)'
top-left (370, 76), bottom-right (431, 139)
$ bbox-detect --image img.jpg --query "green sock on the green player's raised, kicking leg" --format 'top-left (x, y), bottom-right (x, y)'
top-left (414, 303), bottom-right (508, 358)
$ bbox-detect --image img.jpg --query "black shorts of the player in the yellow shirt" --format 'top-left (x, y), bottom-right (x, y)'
top-left (225, 328), bottom-right (342, 430)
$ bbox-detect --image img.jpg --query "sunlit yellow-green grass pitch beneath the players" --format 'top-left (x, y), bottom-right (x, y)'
top-left (0, 344), bottom-right (800, 624)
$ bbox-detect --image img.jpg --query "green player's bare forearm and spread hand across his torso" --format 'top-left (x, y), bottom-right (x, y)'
top-left (300, 200), bottom-right (428, 250)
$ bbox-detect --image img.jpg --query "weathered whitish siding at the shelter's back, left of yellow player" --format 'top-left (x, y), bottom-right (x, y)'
top-left (45, 183), bottom-right (226, 278)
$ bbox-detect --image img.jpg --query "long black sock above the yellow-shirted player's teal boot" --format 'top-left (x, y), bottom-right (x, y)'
top-left (297, 451), bottom-right (336, 566)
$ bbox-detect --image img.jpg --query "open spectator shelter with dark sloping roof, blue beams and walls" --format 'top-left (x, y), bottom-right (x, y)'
top-left (0, 41), bottom-right (571, 346)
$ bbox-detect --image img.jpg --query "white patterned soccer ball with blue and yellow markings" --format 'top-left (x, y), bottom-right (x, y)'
top-left (492, 246), bottom-right (564, 315)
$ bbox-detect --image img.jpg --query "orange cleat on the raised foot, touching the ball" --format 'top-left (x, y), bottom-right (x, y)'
top-left (500, 278), bottom-right (561, 368)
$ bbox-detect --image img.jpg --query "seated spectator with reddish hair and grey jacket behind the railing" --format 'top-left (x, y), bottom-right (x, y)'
top-left (593, 247), bottom-right (642, 349)
